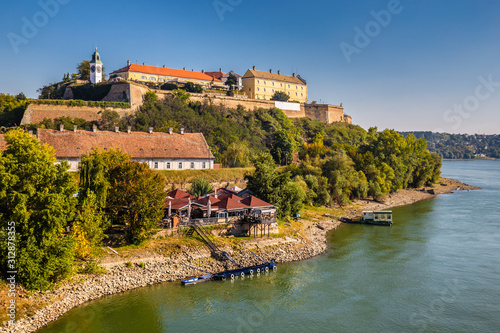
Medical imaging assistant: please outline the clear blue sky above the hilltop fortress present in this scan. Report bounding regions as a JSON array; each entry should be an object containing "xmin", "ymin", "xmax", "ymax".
[{"xmin": 0, "ymin": 0, "xmax": 500, "ymax": 134}]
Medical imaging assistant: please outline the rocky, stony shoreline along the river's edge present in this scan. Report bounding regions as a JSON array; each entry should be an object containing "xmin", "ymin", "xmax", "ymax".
[{"xmin": 0, "ymin": 178, "xmax": 479, "ymax": 333}]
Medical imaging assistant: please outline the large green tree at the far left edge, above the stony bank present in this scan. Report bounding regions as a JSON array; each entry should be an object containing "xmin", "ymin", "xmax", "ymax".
[{"xmin": 0, "ymin": 129, "xmax": 76, "ymax": 289}]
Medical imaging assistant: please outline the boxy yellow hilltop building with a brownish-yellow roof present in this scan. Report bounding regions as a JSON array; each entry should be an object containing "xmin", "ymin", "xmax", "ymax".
[{"xmin": 243, "ymin": 66, "xmax": 307, "ymax": 103}]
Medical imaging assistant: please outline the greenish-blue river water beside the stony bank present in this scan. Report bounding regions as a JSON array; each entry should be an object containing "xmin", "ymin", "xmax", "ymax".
[{"xmin": 40, "ymin": 161, "xmax": 500, "ymax": 333}]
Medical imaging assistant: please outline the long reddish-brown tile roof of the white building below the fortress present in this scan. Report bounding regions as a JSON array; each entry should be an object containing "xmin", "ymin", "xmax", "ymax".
[{"xmin": 37, "ymin": 128, "xmax": 214, "ymax": 159}]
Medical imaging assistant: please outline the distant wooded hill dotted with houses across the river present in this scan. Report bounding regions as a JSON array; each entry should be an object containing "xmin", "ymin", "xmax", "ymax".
[{"xmin": 399, "ymin": 132, "xmax": 500, "ymax": 159}]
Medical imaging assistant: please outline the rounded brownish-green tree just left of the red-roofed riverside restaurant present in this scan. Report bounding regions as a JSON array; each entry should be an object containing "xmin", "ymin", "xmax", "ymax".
[{"xmin": 107, "ymin": 161, "xmax": 165, "ymax": 244}]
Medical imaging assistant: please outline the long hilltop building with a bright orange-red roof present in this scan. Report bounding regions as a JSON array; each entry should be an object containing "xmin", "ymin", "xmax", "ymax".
[{"xmin": 111, "ymin": 61, "xmax": 223, "ymax": 88}]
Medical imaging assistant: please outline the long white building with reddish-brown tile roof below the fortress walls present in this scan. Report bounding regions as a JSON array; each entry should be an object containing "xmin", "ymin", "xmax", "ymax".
[{"xmin": 36, "ymin": 125, "xmax": 214, "ymax": 171}]
